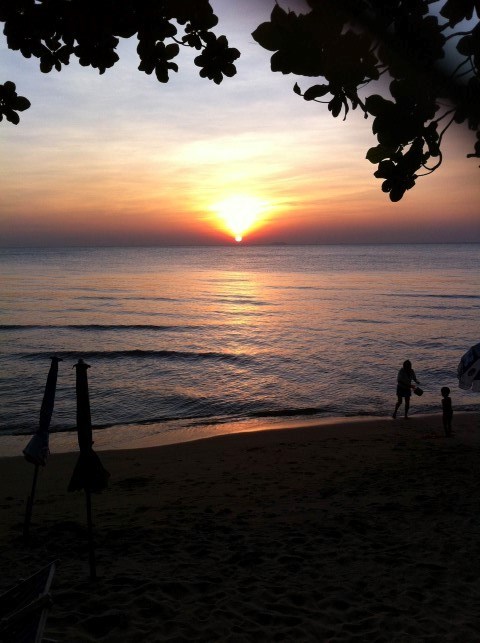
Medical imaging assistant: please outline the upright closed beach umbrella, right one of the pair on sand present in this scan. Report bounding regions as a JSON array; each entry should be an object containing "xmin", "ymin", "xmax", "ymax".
[{"xmin": 68, "ymin": 359, "xmax": 110, "ymax": 579}]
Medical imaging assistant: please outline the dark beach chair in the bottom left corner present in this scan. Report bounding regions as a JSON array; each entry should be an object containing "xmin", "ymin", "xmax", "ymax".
[{"xmin": 0, "ymin": 562, "xmax": 55, "ymax": 643}]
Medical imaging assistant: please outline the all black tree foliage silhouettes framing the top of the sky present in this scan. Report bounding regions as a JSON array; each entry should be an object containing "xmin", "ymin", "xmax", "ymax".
[{"xmin": 0, "ymin": 0, "xmax": 480, "ymax": 201}]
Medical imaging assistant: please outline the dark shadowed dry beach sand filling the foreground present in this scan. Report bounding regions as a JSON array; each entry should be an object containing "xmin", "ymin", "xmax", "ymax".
[{"xmin": 0, "ymin": 414, "xmax": 480, "ymax": 643}]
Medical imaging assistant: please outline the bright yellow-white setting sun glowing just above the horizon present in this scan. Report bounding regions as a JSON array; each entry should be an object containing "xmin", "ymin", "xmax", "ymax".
[{"xmin": 212, "ymin": 195, "xmax": 266, "ymax": 243}]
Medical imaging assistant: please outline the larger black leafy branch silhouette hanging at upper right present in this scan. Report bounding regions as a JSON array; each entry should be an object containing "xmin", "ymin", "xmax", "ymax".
[{"xmin": 253, "ymin": 0, "xmax": 480, "ymax": 201}]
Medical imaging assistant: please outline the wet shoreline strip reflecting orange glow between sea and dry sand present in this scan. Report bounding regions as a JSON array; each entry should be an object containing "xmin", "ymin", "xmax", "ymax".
[{"xmin": 0, "ymin": 411, "xmax": 475, "ymax": 458}]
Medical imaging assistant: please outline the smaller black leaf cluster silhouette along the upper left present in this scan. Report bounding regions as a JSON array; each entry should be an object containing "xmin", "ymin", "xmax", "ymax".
[{"xmin": 0, "ymin": 0, "xmax": 240, "ymax": 124}]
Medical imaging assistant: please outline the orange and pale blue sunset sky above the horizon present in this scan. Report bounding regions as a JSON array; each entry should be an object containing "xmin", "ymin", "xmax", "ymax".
[{"xmin": 0, "ymin": 0, "xmax": 480, "ymax": 246}]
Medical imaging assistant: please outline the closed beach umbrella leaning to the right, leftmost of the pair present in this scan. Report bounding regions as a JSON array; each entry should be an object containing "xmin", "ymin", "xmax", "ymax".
[{"xmin": 23, "ymin": 357, "xmax": 62, "ymax": 538}]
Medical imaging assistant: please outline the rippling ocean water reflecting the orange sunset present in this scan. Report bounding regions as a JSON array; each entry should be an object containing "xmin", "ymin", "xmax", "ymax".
[{"xmin": 0, "ymin": 244, "xmax": 480, "ymax": 446}]
